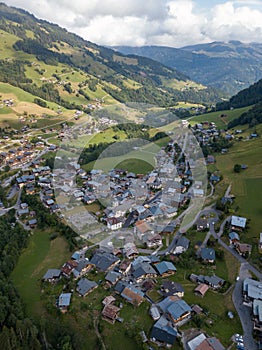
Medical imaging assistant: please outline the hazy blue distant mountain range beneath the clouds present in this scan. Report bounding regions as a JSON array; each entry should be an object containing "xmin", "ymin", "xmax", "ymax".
[{"xmin": 115, "ymin": 41, "xmax": 262, "ymax": 95}]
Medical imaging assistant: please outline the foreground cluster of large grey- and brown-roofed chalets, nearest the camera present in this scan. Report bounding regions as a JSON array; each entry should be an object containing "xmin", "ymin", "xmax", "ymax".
[{"xmin": 43, "ymin": 248, "xmax": 211, "ymax": 346}]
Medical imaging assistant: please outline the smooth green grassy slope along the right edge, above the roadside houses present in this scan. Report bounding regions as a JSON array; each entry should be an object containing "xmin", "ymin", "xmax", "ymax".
[{"xmin": 212, "ymin": 125, "xmax": 262, "ymax": 266}]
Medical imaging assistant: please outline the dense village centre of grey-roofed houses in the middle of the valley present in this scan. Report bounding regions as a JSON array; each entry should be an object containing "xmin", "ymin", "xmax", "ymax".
[{"xmin": 52, "ymin": 135, "xmax": 207, "ymax": 248}]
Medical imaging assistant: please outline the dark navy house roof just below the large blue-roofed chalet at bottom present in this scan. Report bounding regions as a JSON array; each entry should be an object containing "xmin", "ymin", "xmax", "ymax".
[{"xmin": 150, "ymin": 316, "xmax": 177, "ymax": 345}]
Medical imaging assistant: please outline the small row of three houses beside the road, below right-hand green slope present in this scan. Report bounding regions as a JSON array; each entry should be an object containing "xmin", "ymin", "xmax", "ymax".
[{"xmin": 228, "ymin": 215, "xmax": 252, "ymax": 258}]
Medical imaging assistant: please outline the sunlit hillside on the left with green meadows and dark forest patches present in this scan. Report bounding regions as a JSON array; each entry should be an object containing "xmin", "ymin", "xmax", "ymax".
[{"xmin": 0, "ymin": 3, "xmax": 222, "ymax": 122}]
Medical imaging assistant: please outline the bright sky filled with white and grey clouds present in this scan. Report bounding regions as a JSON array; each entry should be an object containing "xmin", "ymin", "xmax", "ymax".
[{"xmin": 3, "ymin": 0, "xmax": 262, "ymax": 47}]
